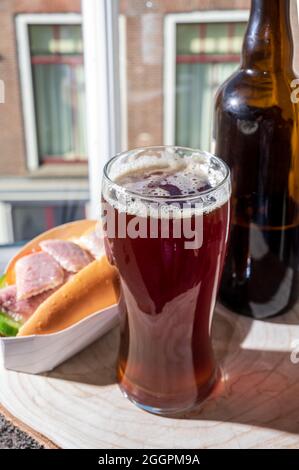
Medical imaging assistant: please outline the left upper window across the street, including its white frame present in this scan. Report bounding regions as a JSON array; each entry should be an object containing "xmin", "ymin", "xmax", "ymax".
[{"xmin": 17, "ymin": 14, "xmax": 87, "ymax": 170}]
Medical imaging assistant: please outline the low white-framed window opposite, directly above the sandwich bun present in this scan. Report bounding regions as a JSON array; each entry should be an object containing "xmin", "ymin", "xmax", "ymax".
[{"xmin": 0, "ymin": 178, "xmax": 89, "ymax": 245}]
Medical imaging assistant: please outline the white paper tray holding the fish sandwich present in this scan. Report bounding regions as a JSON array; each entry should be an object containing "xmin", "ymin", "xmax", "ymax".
[{"xmin": 0, "ymin": 305, "xmax": 118, "ymax": 374}]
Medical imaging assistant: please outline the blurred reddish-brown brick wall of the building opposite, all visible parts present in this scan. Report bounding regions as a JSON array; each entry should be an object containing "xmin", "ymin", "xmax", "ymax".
[{"xmin": 0, "ymin": 0, "xmax": 299, "ymax": 176}]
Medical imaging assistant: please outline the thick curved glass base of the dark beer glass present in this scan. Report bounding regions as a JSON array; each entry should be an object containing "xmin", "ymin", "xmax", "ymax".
[{"xmin": 118, "ymin": 368, "xmax": 222, "ymax": 417}]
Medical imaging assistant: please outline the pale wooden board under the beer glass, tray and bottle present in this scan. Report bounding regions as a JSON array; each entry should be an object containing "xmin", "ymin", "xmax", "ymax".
[{"xmin": 0, "ymin": 306, "xmax": 299, "ymax": 449}]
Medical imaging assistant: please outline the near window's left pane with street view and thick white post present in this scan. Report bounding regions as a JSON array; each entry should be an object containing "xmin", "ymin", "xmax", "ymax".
[{"xmin": 0, "ymin": 0, "xmax": 120, "ymax": 246}]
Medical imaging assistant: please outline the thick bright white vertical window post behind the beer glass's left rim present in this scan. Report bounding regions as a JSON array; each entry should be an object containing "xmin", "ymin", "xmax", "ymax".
[{"xmin": 82, "ymin": 0, "xmax": 121, "ymax": 219}]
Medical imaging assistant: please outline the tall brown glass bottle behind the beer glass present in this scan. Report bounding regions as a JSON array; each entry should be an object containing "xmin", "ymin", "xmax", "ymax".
[{"xmin": 215, "ymin": 0, "xmax": 299, "ymax": 318}]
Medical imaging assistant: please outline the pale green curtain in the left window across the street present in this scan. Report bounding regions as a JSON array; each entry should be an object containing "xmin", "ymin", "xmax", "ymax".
[{"xmin": 33, "ymin": 64, "xmax": 86, "ymax": 159}]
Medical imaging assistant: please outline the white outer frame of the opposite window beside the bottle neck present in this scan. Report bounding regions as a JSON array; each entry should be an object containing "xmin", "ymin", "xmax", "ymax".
[{"xmin": 163, "ymin": 10, "xmax": 249, "ymax": 145}]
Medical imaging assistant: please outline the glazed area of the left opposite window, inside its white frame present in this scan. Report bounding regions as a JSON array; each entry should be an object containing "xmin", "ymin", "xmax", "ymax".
[{"xmin": 29, "ymin": 25, "xmax": 86, "ymax": 163}]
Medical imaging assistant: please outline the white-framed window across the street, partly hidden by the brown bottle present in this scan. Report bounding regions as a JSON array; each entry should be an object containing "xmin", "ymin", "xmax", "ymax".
[{"xmin": 164, "ymin": 11, "xmax": 247, "ymax": 150}]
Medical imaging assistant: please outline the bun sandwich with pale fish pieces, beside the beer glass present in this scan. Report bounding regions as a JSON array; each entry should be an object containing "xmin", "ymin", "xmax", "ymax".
[{"xmin": 0, "ymin": 220, "xmax": 119, "ymax": 336}]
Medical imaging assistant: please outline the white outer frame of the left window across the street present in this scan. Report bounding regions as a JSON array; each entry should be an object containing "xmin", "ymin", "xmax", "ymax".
[{"xmin": 16, "ymin": 13, "xmax": 82, "ymax": 171}]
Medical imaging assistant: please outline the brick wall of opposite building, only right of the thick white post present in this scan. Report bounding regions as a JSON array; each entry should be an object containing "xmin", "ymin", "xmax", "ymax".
[{"xmin": 121, "ymin": 0, "xmax": 299, "ymax": 148}]
